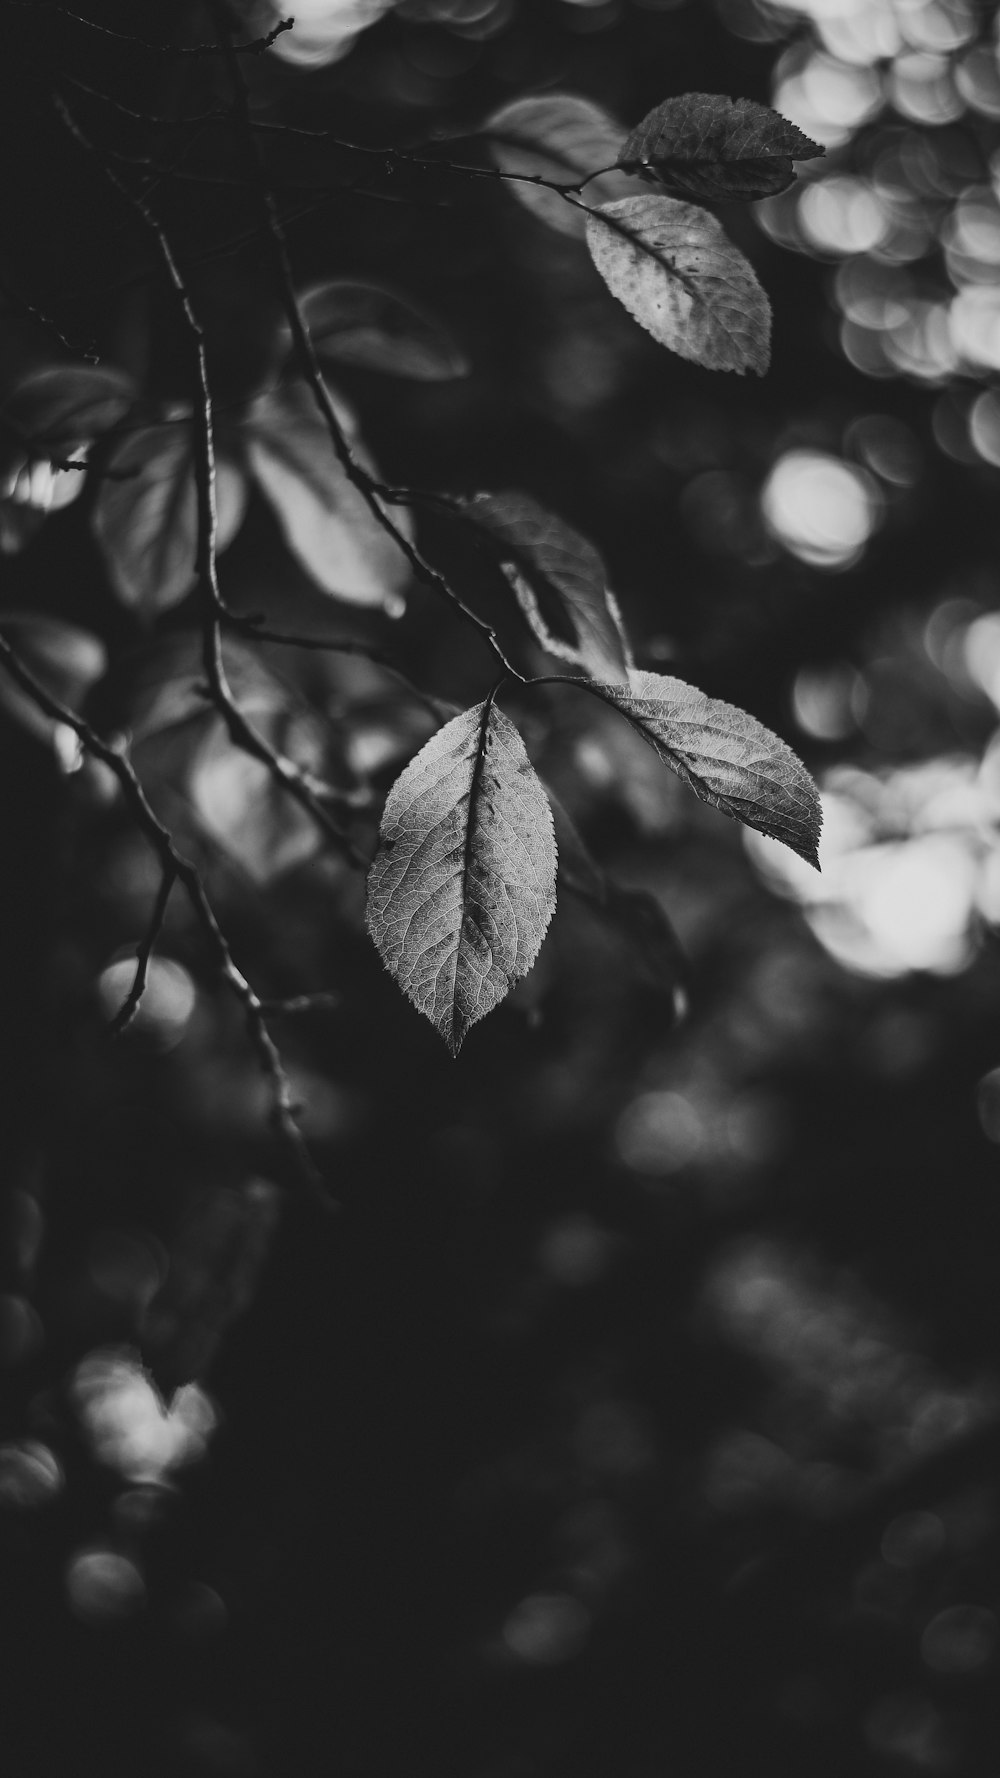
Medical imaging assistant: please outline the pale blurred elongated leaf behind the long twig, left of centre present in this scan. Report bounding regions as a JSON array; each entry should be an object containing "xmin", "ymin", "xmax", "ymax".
[{"xmin": 244, "ymin": 382, "xmax": 413, "ymax": 617}]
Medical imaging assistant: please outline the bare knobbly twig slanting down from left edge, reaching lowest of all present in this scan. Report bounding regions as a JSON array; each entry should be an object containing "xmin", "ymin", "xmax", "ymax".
[{"xmin": 0, "ymin": 635, "xmax": 336, "ymax": 1209}]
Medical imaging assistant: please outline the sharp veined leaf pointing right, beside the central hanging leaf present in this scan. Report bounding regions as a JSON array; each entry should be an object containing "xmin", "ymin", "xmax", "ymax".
[{"xmin": 607, "ymin": 669, "xmax": 822, "ymax": 869}]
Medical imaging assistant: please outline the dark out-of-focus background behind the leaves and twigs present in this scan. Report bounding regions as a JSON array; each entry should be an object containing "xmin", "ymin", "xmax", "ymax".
[{"xmin": 0, "ymin": 0, "xmax": 1000, "ymax": 1778}]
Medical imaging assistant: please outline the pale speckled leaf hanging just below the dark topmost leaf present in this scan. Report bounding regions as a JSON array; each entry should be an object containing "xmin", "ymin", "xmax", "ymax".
[{"xmin": 587, "ymin": 196, "xmax": 770, "ymax": 377}]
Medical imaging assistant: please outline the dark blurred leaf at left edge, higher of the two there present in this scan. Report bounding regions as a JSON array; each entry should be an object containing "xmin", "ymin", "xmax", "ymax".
[{"xmin": 0, "ymin": 364, "xmax": 135, "ymax": 459}]
